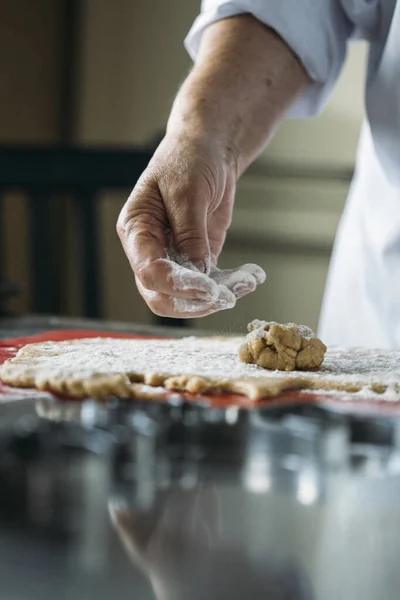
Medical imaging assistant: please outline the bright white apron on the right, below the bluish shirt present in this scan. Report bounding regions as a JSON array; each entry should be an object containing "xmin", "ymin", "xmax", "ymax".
[{"xmin": 319, "ymin": 122, "xmax": 400, "ymax": 348}]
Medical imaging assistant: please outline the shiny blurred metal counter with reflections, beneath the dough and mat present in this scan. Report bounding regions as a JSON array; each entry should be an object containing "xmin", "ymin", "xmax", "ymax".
[{"xmin": 0, "ymin": 319, "xmax": 400, "ymax": 600}]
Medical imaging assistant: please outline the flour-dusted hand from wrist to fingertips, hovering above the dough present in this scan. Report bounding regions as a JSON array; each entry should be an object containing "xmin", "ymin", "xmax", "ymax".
[{"xmin": 117, "ymin": 133, "xmax": 265, "ymax": 318}]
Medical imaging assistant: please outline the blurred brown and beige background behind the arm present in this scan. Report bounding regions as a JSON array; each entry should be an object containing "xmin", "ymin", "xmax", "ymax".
[{"xmin": 0, "ymin": 0, "xmax": 366, "ymax": 333}]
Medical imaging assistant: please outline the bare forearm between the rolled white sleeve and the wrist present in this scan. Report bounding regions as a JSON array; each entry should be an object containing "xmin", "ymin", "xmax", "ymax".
[{"xmin": 167, "ymin": 15, "xmax": 310, "ymax": 175}]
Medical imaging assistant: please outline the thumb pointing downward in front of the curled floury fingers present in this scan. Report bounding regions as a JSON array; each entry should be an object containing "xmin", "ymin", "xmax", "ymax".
[{"xmin": 166, "ymin": 189, "xmax": 210, "ymax": 273}]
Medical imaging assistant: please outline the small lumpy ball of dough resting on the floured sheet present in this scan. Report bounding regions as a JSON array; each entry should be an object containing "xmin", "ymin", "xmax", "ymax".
[{"xmin": 239, "ymin": 320, "xmax": 327, "ymax": 371}]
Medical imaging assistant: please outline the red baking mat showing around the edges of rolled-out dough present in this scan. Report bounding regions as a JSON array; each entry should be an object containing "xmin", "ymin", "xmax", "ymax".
[{"xmin": 0, "ymin": 329, "xmax": 400, "ymax": 416}]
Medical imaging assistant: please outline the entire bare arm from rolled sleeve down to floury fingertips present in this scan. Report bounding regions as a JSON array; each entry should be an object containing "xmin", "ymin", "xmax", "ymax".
[{"xmin": 118, "ymin": 15, "xmax": 310, "ymax": 317}]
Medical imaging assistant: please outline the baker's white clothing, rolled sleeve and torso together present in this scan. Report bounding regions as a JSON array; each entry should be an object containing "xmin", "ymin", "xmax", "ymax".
[{"xmin": 186, "ymin": 0, "xmax": 400, "ymax": 348}]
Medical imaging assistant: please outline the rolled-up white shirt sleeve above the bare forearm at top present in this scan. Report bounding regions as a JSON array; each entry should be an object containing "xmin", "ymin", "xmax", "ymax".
[{"xmin": 185, "ymin": 0, "xmax": 377, "ymax": 118}]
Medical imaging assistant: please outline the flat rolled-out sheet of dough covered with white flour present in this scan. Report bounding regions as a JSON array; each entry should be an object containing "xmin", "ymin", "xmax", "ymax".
[{"xmin": 0, "ymin": 338, "xmax": 400, "ymax": 401}]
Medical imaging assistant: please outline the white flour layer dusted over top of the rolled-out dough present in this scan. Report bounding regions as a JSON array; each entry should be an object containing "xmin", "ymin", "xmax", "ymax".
[{"xmin": 0, "ymin": 337, "xmax": 400, "ymax": 401}]
